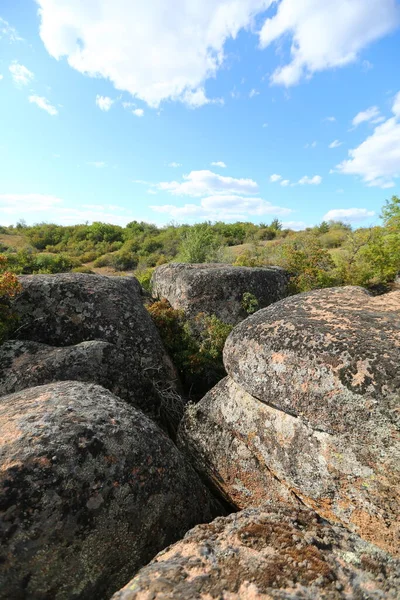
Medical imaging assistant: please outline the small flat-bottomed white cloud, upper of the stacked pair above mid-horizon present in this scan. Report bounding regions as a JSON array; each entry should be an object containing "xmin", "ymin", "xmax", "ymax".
[{"xmin": 155, "ymin": 170, "xmax": 258, "ymax": 196}]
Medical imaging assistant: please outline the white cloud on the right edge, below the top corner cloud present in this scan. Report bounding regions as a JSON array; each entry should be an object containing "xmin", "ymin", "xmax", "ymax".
[{"xmin": 336, "ymin": 93, "xmax": 400, "ymax": 189}]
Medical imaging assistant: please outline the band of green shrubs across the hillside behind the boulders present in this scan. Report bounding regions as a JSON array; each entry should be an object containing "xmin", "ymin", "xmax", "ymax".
[{"xmin": 0, "ymin": 196, "xmax": 400, "ymax": 292}]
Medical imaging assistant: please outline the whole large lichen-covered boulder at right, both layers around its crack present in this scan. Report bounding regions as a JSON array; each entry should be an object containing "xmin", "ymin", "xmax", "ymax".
[{"xmin": 179, "ymin": 288, "xmax": 400, "ymax": 553}]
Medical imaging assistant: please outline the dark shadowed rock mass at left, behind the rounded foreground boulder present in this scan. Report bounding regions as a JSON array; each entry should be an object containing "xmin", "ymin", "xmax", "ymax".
[{"xmin": 6, "ymin": 273, "xmax": 182, "ymax": 428}]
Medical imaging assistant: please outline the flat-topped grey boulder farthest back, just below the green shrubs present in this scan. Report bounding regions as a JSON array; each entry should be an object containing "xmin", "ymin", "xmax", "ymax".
[{"xmin": 152, "ymin": 263, "xmax": 289, "ymax": 325}]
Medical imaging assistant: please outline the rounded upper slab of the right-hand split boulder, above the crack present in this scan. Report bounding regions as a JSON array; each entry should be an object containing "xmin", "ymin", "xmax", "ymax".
[{"xmin": 224, "ymin": 287, "xmax": 400, "ymax": 433}]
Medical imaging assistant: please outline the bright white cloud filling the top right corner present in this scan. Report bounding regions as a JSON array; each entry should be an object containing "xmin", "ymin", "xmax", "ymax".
[{"xmin": 260, "ymin": 0, "xmax": 400, "ymax": 86}]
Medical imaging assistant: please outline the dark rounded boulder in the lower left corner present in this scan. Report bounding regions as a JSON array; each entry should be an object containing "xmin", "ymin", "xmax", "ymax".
[{"xmin": 0, "ymin": 382, "xmax": 222, "ymax": 600}]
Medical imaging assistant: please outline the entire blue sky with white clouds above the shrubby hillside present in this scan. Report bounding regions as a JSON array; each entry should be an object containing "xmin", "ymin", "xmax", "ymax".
[{"xmin": 0, "ymin": 0, "xmax": 400, "ymax": 229}]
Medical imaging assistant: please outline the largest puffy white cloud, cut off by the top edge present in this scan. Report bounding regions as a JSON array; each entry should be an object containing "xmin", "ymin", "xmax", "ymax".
[{"xmin": 37, "ymin": 0, "xmax": 272, "ymax": 107}]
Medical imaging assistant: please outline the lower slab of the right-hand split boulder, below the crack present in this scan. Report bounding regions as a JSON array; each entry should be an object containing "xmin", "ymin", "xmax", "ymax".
[{"xmin": 178, "ymin": 377, "xmax": 400, "ymax": 553}]
